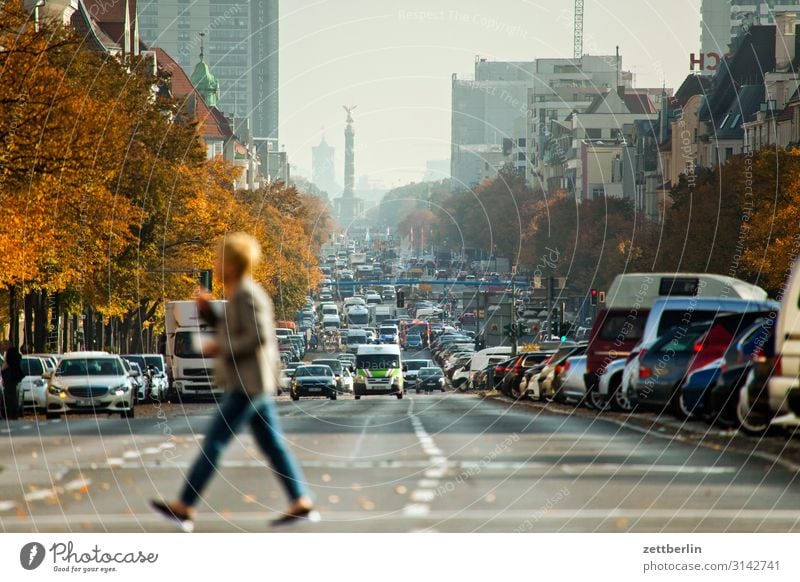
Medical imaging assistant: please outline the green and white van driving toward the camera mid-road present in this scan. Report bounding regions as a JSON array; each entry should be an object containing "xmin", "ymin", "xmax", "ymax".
[{"xmin": 353, "ymin": 344, "xmax": 405, "ymax": 400}]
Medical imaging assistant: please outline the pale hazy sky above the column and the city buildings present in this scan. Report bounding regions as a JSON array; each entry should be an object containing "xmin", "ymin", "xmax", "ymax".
[{"xmin": 280, "ymin": 0, "xmax": 700, "ymax": 187}]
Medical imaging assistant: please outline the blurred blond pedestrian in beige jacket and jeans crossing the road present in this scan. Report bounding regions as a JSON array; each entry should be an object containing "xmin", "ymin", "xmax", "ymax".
[{"xmin": 151, "ymin": 233, "xmax": 319, "ymax": 531}]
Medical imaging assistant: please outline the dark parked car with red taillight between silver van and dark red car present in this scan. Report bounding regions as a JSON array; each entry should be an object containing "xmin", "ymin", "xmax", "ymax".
[{"xmin": 630, "ymin": 321, "xmax": 711, "ymax": 415}]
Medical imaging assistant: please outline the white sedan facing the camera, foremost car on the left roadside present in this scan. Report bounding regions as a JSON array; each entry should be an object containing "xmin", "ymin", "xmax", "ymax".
[{"xmin": 46, "ymin": 352, "xmax": 135, "ymax": 419}]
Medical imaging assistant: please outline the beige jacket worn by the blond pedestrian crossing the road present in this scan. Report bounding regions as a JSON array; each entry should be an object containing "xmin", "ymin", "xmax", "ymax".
[{"xmin": 203, "ymin": 277, "xmax": 280, "ymax": 396}]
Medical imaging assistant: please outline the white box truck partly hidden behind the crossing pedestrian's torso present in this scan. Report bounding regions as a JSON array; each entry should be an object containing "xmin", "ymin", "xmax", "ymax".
[{"xmin": 164, "ymin": 301, "xmax": 225, "ymax": 399}]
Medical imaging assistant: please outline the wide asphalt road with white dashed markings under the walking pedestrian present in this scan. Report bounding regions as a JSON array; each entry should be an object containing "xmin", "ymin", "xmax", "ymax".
[{"xmin": 0, "ymin": 352, "xmax": 800, "ymax": 532}]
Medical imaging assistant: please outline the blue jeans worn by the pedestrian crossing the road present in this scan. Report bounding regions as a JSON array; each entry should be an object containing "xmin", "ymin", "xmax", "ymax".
[{"xmin": 181, "ymin": 391, "xmax": 310, "ymax": 506}]
